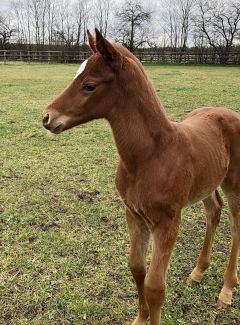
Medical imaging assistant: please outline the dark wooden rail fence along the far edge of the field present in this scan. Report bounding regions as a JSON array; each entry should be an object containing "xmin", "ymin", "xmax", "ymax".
[{"xmin": 0, "ymin": 49, "xmax": 240, "ymax": 64}]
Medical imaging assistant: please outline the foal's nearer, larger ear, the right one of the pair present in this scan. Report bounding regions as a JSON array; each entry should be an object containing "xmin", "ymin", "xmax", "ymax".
[{"xmin": 95, "ymin": 28, "xmax": 122, "ymax": 69}]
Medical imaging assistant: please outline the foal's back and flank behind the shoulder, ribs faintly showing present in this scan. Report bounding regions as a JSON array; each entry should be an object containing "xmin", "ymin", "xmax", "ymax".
[{"xmin": 179, "ymin": 107, "xmax": 240, "ymax": 203}]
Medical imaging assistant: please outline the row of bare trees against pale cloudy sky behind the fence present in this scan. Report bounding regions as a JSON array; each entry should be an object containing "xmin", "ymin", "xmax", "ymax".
[{"xmin": 0, "ymin": 0, "xmax": 240, "ymax": 63}]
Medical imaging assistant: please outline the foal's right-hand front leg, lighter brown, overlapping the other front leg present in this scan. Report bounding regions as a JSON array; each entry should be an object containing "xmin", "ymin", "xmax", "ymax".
[{"xmin": 144, "ymin": 214, "xmax": 180, "ymax": 325}]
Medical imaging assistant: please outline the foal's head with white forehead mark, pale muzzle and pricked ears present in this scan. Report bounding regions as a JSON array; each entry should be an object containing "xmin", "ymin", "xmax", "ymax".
[{"xmin": 43, "ymin": 30, "xmax": 143, "ymax": 133}]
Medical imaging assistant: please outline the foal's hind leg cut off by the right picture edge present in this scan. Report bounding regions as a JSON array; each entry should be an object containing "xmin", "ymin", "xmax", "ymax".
[{"xmin": 218, "ymin": 181, "xmax": 240, "ymax": 307}]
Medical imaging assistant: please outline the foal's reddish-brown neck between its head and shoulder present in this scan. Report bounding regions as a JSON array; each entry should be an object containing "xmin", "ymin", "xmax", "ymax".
[{"xmin": 108, "ymin": 64, "xmax": 172, "ymax": 173}]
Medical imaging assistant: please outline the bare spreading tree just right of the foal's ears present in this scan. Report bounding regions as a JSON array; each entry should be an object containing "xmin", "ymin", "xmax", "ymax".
[{"xmin": 116, "ymin": 0, "xmax": 151, "ymax": 52}]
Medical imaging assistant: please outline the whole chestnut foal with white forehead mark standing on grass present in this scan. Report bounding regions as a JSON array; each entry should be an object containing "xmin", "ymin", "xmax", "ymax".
[{"xmin": 43, "ymin": 30, "xmax": 240, "ymax": 325}]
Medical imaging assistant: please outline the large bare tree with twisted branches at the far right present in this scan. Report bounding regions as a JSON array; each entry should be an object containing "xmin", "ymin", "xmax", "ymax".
[{"xmin": 195, "ymin": 0, "xmax": 240, "ymax": 64}]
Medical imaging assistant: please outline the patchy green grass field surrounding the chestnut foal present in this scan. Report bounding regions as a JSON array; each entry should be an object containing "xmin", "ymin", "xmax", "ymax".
[{"xmin": 0, "ymin": 64, "xmax": 240, "ymax": 325}]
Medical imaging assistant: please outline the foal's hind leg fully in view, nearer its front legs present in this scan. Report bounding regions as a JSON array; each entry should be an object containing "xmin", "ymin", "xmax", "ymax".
[{"xmin": 188, "ymin": 190, "xmax": 223, "ymax": 283}]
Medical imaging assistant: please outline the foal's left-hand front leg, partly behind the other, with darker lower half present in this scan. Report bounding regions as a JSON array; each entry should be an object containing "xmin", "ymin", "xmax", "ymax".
[{"xmin": 126, "ymin": 209, "xmax": 150, "ymax": 325}]
